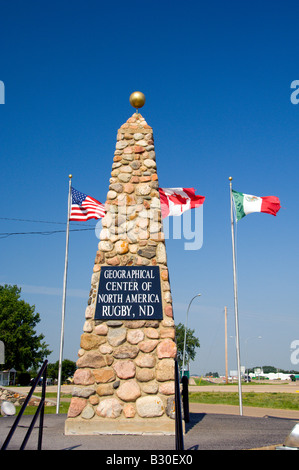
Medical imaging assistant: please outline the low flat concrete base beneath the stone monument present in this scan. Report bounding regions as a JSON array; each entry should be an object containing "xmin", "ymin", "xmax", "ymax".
[{"xmin": 64, "ymin": 417, "xmax": 175, "ymax": 436}]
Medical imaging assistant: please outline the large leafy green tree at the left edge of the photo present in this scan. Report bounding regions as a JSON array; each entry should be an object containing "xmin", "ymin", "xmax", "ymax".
[{"xmin": 0, "ymin": 284, "xmax": 52, "ymax": 372}]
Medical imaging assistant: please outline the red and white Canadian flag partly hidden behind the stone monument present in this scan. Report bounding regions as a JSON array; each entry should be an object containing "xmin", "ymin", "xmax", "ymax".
[{"xmin": 159, "ymin": 188, "xmax": 205, "ymax": 219}]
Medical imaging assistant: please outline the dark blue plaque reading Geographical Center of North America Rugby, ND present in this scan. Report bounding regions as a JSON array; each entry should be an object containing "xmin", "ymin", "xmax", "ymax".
[{"xmin": 94, "ymin": 266, "xmax": 163, "ymax": 320}]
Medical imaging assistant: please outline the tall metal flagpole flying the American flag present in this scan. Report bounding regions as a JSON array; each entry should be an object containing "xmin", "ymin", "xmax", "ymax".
[{"xmin": 56, "ymin": 175, "xmax": 72, "ymax": 414}]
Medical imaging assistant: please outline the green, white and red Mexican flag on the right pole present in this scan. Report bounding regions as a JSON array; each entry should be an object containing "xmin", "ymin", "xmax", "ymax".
[{"xmin": 232, "ymin": 190, "xmax": 280, "ymax": 220}]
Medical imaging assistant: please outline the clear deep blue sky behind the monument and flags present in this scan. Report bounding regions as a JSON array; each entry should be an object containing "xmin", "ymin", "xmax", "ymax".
[{"xmin": 0, "ymin": 0, "xmax": 299, "ymax": 374}]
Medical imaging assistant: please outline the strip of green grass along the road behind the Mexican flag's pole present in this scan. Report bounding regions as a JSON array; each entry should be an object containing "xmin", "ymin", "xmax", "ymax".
[{"xmin": 189, "ymin": 392, "xmax": 299, "ymax": 410}]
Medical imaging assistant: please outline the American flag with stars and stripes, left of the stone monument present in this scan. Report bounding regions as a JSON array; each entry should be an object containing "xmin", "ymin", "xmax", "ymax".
[{"xmin": 70, "ymin": 188, "xmax": 105, "ymax": 221}]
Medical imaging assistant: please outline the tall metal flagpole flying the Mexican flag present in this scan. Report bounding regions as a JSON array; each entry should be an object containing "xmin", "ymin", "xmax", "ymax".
[{"xmin": 229, "ymin": 176, "xmax": 243, "ymax": 416}]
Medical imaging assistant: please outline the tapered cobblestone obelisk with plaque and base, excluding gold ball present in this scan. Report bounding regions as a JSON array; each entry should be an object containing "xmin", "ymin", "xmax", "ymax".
[{"xmin": 65, "ymin": 101, "xmax": 176, "ymax": 435}]
